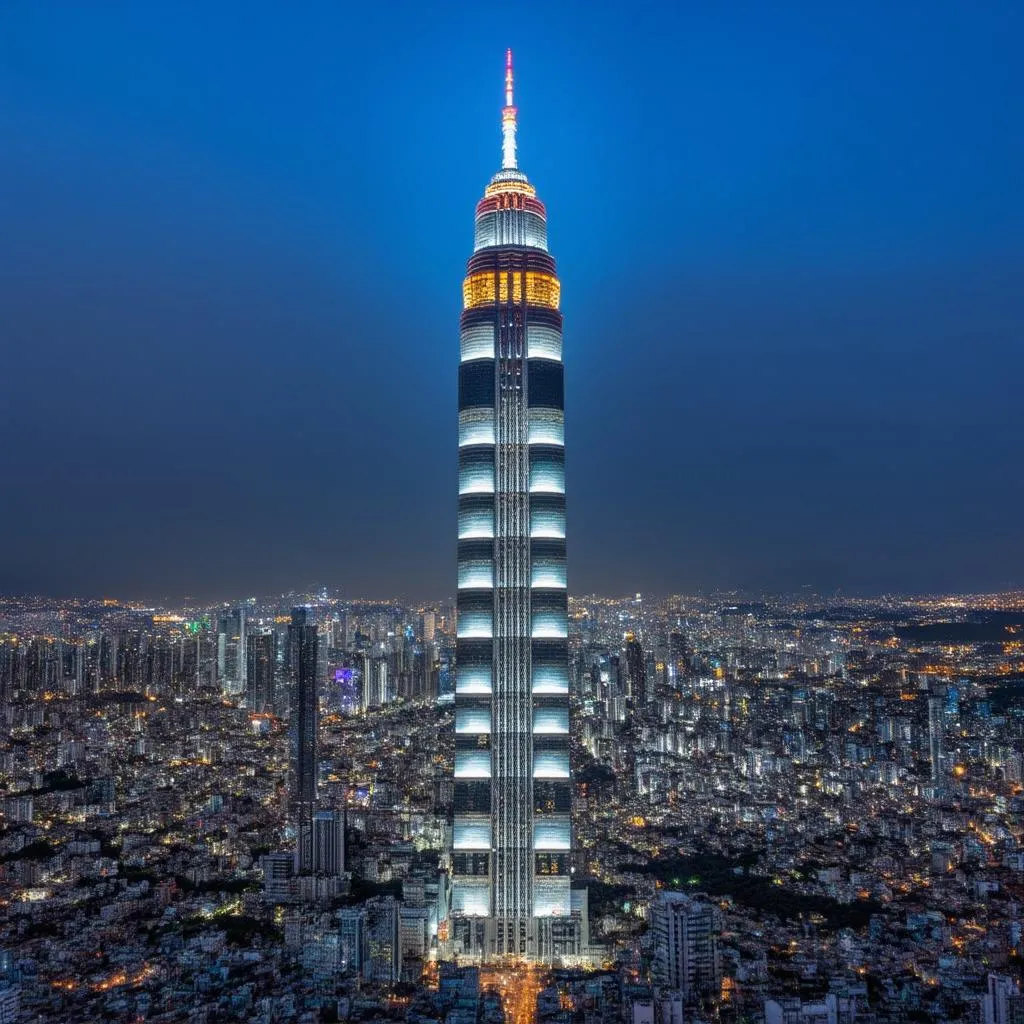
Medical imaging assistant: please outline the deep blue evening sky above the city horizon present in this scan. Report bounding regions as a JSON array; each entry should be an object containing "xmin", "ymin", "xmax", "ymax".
[{"xmin": 0, "ymin": 0, "xmax": 1024, "ymax": 599}]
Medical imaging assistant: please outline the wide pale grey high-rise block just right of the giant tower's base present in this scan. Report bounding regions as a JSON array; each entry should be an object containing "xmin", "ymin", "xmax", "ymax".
[{"xmin": 651, "ymin": 892, "xmax": 722, "ymax": 1002}]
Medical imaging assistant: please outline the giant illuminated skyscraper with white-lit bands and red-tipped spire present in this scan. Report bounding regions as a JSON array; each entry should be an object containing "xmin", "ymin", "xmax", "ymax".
[{"xmin": 452, "ymin": 51, "xmax": 579, "ymax": 959}]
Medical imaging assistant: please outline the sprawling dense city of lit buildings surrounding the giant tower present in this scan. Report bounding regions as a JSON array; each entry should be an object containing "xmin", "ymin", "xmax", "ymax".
[{"xmin": 0, "ymin": 592, "xmax": 1024, "ymax": 1024}]
